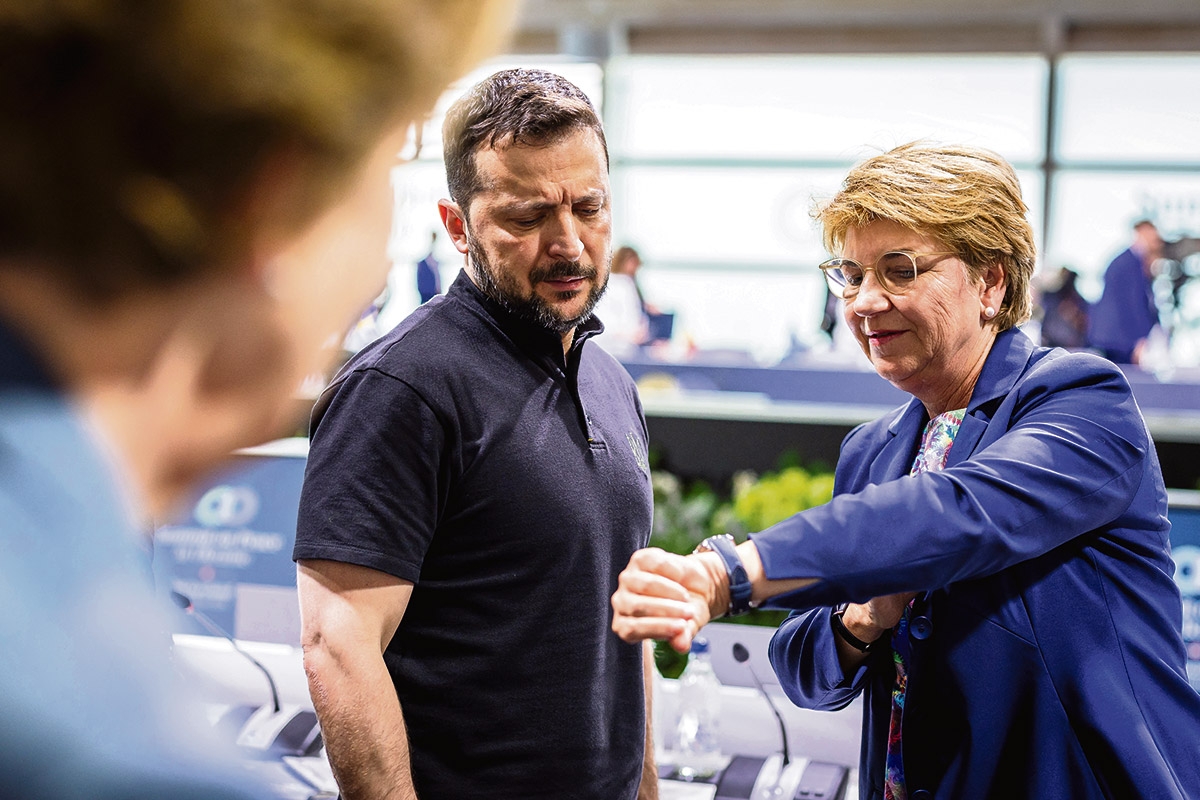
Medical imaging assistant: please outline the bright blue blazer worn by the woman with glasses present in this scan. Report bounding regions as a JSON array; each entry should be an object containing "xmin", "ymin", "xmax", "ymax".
[{"xmin": 752, "ymin": 330, "xmax": 1200, "ymax": 800}]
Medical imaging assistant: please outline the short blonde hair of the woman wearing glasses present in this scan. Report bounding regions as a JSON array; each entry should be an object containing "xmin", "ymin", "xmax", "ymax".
[{"xmin": 814, "ymin": 142, "xmax": 1037, "ymax": 330}]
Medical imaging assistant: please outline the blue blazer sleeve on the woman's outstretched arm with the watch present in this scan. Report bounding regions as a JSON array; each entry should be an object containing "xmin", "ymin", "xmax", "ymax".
[{"xmin": 752, "ymin": 351, "xmax": 1165, "ymax": 608}]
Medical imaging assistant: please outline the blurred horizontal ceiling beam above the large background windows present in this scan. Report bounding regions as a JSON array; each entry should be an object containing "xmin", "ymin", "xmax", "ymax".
[{"xmin": 512, "ymin": 0, "xmax": 1200, "ymax": 60}]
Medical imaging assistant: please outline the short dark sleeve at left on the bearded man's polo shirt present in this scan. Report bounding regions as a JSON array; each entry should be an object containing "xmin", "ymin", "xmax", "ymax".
[{"xmin": 293, "ymin": 369, "xmax": 445, "ymax": 583}]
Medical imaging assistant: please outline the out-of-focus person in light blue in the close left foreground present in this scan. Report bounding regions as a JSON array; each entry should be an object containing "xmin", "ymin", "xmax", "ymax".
[{"xmin": 0, "ymin": 0, "xmax": 510, "ymax": 799}]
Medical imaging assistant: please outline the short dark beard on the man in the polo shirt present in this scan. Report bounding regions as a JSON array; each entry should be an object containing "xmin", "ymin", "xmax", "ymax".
[{"xmin": 467, "ymin": 239, "xmax": 608, "ymax": 336}]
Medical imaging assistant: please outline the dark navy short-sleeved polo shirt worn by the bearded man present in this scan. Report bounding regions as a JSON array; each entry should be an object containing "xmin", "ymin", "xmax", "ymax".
[{"xmin": 294, "ymin": 273, "xmax": 652, "ymax": 800}]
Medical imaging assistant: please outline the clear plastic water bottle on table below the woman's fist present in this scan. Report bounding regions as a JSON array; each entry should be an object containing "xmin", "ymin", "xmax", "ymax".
[{"xmin": 674, "ymin": 639, "xmax": 725, "ymax": 781}]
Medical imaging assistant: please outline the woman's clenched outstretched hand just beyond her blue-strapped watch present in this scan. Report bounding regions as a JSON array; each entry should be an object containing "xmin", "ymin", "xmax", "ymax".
[{"xmin": 612, "ymin": 547, "xmax": 728, "ymax": 652}]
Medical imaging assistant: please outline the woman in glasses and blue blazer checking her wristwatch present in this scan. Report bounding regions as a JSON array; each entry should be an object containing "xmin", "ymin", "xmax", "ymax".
[{"xmin": 612, "ymin": 143, "xmax": 1200, "ymax": 800}]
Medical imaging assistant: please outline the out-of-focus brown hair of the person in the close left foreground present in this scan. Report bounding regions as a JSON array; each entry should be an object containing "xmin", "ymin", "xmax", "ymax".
[{"xmin": 0, "ymin": 0, "xmax": 512, "ymax": 301}]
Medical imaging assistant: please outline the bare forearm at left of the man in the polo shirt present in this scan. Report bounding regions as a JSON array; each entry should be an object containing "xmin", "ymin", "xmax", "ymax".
[{"xmin": 305, "ymin": 649, "xmax": 416, "ymax": 800}]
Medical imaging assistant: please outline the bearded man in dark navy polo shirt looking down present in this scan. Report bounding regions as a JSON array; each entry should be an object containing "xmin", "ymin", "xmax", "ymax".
[{"xmin": 294, "ymin": 70, "xmax": 656, "ymax": 800}]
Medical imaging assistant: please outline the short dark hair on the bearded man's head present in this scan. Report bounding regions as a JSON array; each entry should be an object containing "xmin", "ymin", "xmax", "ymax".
[{"xmin": 442, "ymin": 68, "xmax": 608, "ymax": 216}]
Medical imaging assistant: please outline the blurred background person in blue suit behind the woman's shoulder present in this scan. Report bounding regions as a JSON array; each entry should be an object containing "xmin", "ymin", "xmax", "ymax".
[{"xmin": 1087, "ymin": 219, "xmax": 1163, "ymax": 365}]
